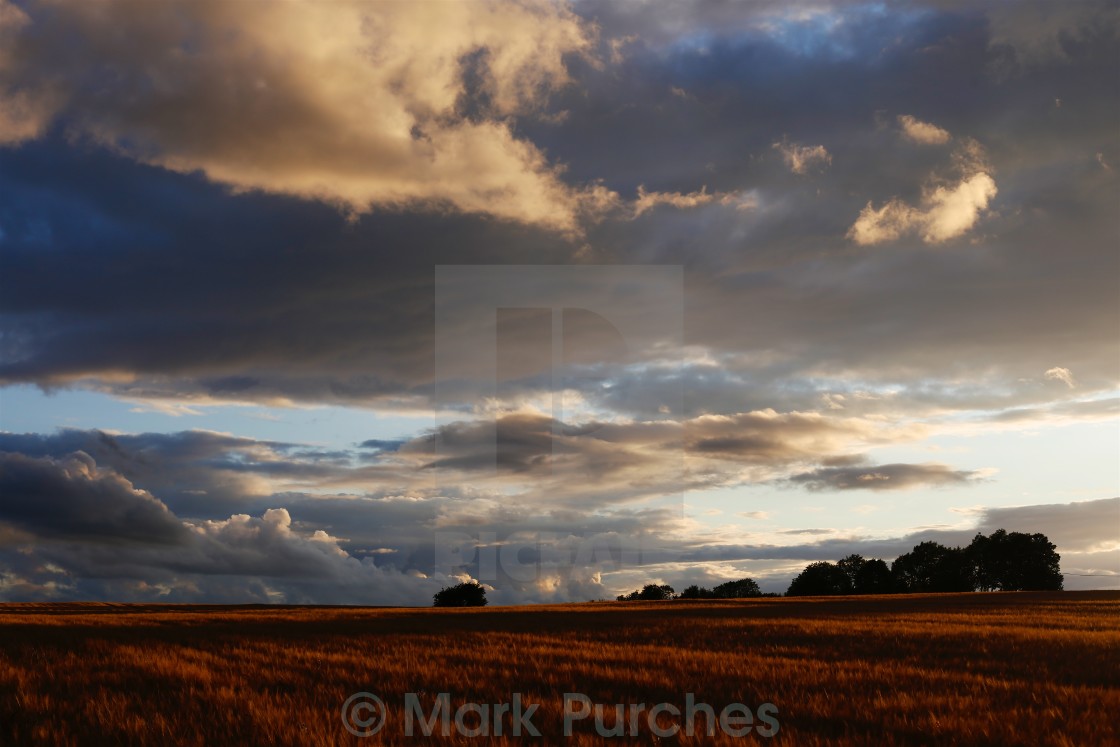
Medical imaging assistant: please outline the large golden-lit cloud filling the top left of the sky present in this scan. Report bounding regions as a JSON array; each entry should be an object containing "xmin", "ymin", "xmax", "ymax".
[{"xmin": 0, "ymin": 0, "xmax": 614, "ymax": 231}]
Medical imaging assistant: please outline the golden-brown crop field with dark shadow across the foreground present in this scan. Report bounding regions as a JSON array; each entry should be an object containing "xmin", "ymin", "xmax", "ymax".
[{"xmin": 0, "ymin": 591, "xmax": 1120, "ymax": 747}]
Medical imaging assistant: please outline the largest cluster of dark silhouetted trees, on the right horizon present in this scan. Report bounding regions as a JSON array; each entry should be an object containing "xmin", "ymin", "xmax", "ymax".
[{"xmin": 786, "ymin": 530, "xmax": 1062, "ymax": 597}]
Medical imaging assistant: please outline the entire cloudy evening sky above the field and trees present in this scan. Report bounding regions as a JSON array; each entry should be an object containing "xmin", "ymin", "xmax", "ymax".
[{"xmin": 0, "ymin": 0, "xmax": 1120, "ymax": 605}]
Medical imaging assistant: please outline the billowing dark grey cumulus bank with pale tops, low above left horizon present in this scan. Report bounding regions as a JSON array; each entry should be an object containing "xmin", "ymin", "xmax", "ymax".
[{"xmin": 0, "ymin": 452, "xmax": 456, "ymax": 604}]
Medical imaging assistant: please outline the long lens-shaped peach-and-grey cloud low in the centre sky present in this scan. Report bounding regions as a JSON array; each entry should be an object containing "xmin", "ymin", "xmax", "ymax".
[{"xmin": 409, "ymin": 410, "xmax": 922, "ymax": 497}]
